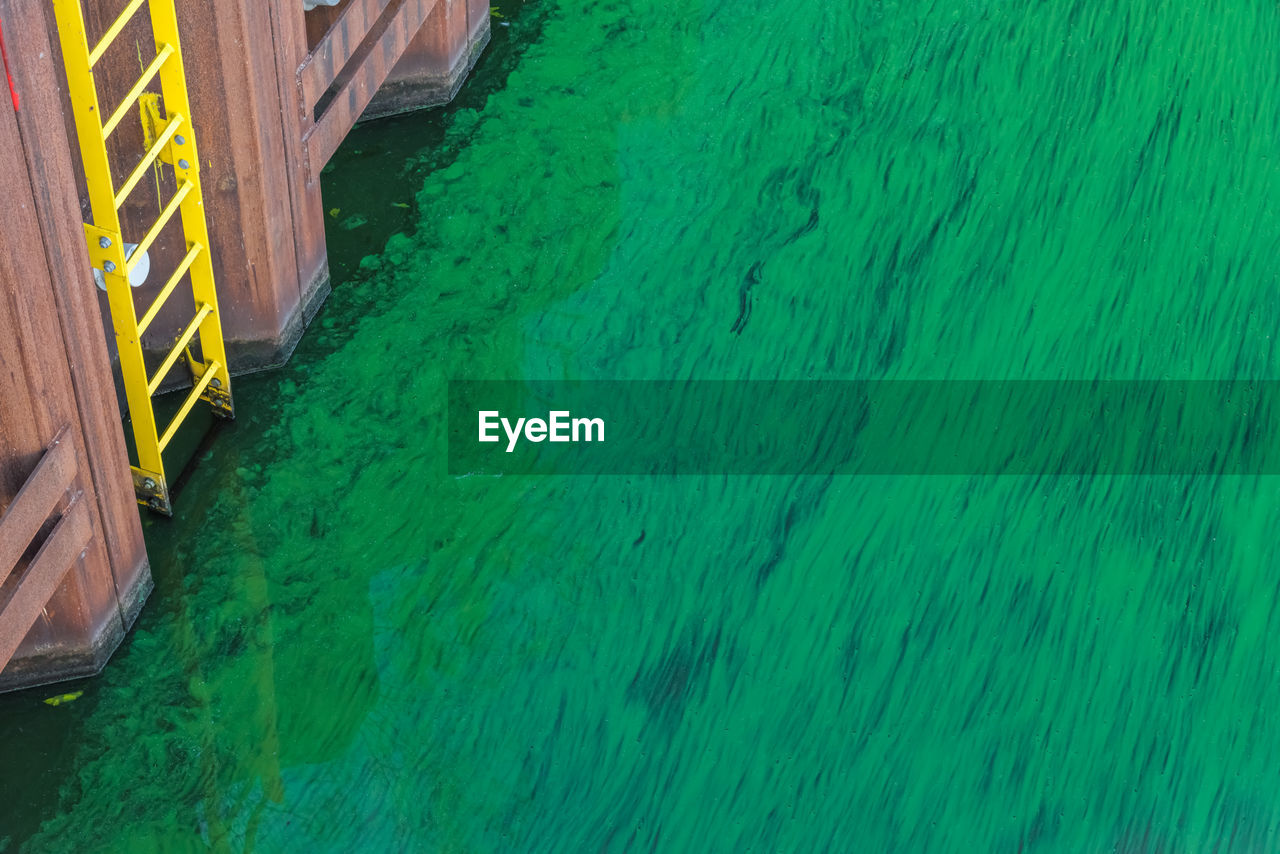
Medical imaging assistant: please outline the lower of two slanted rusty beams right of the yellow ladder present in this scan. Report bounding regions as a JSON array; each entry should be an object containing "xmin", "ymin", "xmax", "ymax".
[{"xmin": 303, "ymin": 0, "xmax": 437, "ymax": 174}]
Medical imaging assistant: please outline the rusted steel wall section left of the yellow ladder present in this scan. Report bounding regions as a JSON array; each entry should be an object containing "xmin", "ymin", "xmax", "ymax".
[{"xmin": 0, "ymin": 0, "xmax": 151, "ymax": 690}]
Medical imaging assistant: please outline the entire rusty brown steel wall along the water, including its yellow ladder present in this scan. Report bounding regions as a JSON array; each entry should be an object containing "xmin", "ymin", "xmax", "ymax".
[{"xmin": 0, "ymin": 0, "xmax": 489, "ymax": 690}]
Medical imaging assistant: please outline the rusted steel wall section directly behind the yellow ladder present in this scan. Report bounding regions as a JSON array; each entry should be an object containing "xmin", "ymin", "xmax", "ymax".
[{"xmin": 59, "ymin": 0, "xmax": 329, "ymax": 378}]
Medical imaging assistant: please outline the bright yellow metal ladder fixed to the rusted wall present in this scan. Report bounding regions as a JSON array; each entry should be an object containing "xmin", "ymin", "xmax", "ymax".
[{"xmin": 52, "ymin": 0, "xmax": 234, "ymax": 515}]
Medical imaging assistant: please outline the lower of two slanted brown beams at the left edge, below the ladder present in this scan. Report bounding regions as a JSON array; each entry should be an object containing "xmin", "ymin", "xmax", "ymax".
[{"xmin": 0, "ymin": 499, "xmax": 93, "ymax": 670}]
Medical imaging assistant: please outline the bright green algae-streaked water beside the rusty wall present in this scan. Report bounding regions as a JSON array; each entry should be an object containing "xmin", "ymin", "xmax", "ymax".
[{"xmin": 0, "ymin": 0, "xmax": 1280, "ymax": 854}]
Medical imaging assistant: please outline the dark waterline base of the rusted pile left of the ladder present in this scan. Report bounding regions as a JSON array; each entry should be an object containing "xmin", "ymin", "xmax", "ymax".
[{"xmin": 0, "ymin": 561, "xmax": 155, "ymax": 694}]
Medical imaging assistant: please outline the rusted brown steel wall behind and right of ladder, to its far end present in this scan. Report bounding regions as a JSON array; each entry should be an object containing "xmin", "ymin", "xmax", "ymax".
[{"xmin": 47, "ymin": 0, "xmax": 489, "ymax": 378}]
